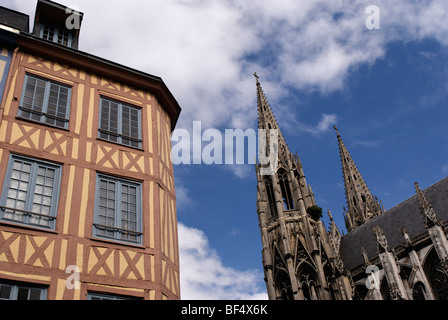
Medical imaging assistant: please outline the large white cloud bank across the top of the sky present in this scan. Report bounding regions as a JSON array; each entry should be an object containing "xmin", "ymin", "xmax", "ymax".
[{"xmin": 8, "ymin": 0, "xmax": 448, "ymax": 135}]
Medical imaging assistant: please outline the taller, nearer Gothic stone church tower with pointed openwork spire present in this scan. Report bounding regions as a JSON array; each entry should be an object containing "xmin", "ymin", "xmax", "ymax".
[{"xmin": 254, "ymin": 74, "xmax": 352, "ymax": 300}]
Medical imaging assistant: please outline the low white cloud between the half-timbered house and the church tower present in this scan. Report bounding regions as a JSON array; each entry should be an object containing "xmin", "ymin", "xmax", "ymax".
[{"xmin": 178, "ymin": 223, "xmax": 267, "ymax": 300}]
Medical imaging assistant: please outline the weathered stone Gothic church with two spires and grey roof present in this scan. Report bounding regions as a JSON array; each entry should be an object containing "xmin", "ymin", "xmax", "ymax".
[{"xmin": 255, "ymin": 75, "xmax": 448, "ymax": 300}]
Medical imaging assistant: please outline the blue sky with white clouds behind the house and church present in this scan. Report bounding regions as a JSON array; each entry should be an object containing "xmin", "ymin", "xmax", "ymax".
[{"xmin": 5, "ymin": 0, "xmax": 448, "ymax": 300}]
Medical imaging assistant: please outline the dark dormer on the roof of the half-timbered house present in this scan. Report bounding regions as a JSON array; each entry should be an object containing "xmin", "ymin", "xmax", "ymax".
[{"xmin": 33, "ymin": 0, "xmax": 83, "ymax": 49}]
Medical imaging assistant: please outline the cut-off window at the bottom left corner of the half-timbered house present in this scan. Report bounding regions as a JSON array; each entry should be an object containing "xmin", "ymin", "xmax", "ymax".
[{"xmin": 0, "ymin": 282, "xmax": 47, "ymax": 300}]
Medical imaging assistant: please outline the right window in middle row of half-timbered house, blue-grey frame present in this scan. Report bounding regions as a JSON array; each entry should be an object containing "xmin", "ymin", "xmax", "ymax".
[{"xmin": 93, "ymin": 174, "xmax": 142, "ymax": 244}]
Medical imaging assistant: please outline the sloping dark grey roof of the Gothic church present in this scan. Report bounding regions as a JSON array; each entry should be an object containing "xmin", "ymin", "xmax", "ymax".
[{"xmin": 340, "ymin": 177, "xmax": 448, "ymax": 270}]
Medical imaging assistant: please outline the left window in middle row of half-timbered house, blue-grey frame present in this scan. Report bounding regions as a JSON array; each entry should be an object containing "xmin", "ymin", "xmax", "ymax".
[{"xmin": 0, "ymin": 155, "xmax": 61, "ymax": 230}]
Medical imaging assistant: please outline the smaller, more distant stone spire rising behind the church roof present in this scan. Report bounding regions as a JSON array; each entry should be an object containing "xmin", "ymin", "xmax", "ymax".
[{"xmin": 334, "ymin": 126, "xmax": 383, "ymax": 232}]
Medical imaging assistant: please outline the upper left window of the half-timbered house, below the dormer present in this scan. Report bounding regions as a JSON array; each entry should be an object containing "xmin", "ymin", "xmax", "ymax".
[{"xmin": 19, "ymin": 75, "xmax": 71, "ymax": 129}]
